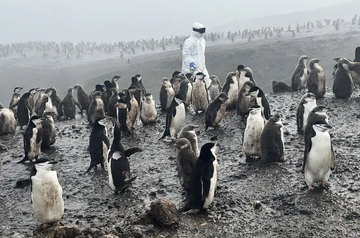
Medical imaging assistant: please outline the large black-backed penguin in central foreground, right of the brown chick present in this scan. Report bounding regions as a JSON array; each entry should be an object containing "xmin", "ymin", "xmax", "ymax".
[{"xmin": 180, "ymin": 143, "xmax": 219, "ymax": 212}]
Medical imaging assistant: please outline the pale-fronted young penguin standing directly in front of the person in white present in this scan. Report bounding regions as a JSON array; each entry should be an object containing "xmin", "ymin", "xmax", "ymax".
[{"xmin": 191, "ymin": 72, "xmax": 209, "ymax": 114}]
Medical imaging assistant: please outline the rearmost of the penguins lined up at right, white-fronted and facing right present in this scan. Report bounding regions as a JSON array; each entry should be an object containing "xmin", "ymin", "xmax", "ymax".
[{"xmin": 296, "ymin": 93, "xmax": 317, "ymax": 134}]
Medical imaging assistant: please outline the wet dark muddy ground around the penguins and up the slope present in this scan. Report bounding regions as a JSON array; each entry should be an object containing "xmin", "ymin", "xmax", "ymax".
[{"xmin": 0, "ymin": 24, "xmax": 360, "ymax": 237}]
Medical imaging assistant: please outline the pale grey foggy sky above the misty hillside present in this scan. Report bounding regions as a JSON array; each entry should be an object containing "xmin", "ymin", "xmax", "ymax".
[{"xmin": 0, "ymin": 0, "xmax": 349, "ymax": 43}]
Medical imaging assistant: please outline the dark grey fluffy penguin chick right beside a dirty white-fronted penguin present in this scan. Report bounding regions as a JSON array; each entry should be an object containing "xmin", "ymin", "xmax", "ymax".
[{"xmin": 260, "ymin": 115, "xmax": 285, "ymax": 164}]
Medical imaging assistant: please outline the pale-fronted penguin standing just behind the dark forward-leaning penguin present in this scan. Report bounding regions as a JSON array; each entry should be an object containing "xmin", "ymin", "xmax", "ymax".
[{"xmin": 223, "ymin": 72, "xmax": 239, "ymax": 109}]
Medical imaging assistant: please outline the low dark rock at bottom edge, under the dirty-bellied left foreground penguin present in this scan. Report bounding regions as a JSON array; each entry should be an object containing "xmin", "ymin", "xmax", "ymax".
[{"xmin": 33, "ymin": 225, "xmax": 80, "ymax": 238}]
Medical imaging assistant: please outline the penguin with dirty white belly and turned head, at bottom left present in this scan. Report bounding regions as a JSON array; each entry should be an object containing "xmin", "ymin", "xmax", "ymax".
[{"xmin": 30, "ymin": 158, "xmax": 64, "ymax": 225}]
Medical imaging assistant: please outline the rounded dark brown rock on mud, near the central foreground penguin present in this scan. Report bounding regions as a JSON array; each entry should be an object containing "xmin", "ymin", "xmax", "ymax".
[{"xmin": 150, "ymin": 198, "xmax": 180, "ymax": 227}]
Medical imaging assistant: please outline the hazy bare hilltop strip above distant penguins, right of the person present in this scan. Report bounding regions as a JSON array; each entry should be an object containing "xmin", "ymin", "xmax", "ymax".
[{"xmin": 209, "ymin": 1, "xmax": 360, "ymax": 32}]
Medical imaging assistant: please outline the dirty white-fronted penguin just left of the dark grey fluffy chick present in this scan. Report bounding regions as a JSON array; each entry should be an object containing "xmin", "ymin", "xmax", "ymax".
[{"xmin": 243, "ymin": 105, "xmax": 265, "ymax": 159}]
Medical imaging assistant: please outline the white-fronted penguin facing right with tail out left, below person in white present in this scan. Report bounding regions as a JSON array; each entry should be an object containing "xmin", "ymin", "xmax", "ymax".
[{"xmin": 159, "ymin": 96, "xmax": 185, "ymax": 140}]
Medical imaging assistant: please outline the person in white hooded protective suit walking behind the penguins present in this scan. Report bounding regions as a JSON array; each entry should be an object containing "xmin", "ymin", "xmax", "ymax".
[{"xmin": 181, "ymin": 22, "xmax": 211, "ymax": 88}]
